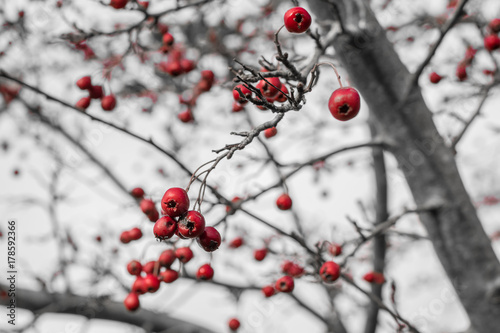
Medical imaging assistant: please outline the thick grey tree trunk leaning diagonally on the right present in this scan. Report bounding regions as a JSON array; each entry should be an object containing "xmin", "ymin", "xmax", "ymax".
[{"xmin": 311, "ymin": 1, "xmax": 500, "ymax": 333}]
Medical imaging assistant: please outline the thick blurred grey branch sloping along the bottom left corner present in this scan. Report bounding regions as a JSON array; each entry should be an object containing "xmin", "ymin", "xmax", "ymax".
[{"xmin": 0, "ymin": 285, "xmax": 213, "ymax": 333}]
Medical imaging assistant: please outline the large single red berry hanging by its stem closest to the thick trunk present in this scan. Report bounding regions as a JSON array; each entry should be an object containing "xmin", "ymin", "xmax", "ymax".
[{"xmin": 328, "ymin": 87, "xmax": 360, "ymax": 121}]
